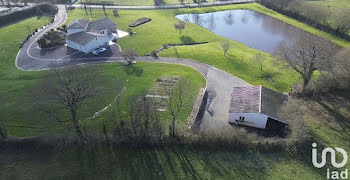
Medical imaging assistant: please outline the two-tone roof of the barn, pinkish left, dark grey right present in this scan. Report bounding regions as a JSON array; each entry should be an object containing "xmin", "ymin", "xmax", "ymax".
[{"xmin": 229, "ymin": 86, "xmax": 287, "ymax": 119}]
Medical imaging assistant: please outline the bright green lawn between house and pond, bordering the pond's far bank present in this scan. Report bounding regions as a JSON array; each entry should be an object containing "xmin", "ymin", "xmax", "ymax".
[{"xmin": 67, "ymin": 3, "xmax": 350, "ymax": 92}]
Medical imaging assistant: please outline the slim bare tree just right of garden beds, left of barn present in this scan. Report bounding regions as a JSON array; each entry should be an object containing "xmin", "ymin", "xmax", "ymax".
[{"xmin": 164, "ymin": 78, "xmax": 194, "ymax": 136}]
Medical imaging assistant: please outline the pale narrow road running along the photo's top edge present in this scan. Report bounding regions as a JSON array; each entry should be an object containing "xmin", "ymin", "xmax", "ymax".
[{"xmin": 73, "ymin": 0, "xmax": 255, "ymax": 10}]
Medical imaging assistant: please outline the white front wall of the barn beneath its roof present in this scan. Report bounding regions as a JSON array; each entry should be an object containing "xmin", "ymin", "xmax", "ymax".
[{"xmin": 229, "ymin": 113, "xmax": 268, "ymax": 129}]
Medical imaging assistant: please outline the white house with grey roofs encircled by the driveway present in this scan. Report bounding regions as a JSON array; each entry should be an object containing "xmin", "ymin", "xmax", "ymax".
[{"xmin": 66, "ymin": 18, "xmax": 118, "ymax": 53}]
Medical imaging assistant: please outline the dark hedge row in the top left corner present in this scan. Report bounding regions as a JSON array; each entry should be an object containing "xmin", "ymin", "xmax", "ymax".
[{"xmin": 0, "ymin": 4, "xmax": 57, "ymax": 26}]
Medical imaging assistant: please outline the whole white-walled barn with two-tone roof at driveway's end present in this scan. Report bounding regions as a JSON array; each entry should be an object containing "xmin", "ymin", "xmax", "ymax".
[{"xmin": 228, "ymin": 86, "xmax": 288, "ymax": 134}]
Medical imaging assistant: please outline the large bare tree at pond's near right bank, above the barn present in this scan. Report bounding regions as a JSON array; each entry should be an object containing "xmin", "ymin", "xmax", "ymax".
[{"xmin": 275, "ymin": 34, "xmax": 335, "ymax": 91}]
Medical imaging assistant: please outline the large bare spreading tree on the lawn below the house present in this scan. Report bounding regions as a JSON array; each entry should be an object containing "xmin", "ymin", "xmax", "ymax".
[{"xmin": 31, "ymin": 67, "xmax": 101, "ymax": 142}]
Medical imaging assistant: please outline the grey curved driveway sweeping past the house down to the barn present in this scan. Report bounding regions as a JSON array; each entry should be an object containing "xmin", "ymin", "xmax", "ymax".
[{"xmin": 16, "ymin": 6, "xmax": 248, "ymax": 133}]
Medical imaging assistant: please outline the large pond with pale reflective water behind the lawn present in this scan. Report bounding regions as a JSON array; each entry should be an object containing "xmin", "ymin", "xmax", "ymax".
[{"xmin": 176, "ymin": 10, "xmax": 314, "ymax": 53}]
